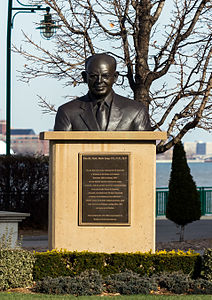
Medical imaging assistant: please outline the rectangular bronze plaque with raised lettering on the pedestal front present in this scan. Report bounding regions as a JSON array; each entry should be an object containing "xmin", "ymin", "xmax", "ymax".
[{"xmin": 79, "ymin": 152, "xmax": 130, "ymax": 226}]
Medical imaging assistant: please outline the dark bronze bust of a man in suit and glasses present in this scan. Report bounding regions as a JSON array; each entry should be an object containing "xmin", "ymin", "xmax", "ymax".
[{"xmin": 54, "ymin": 53, "xmax": 151, "ymax": 131}]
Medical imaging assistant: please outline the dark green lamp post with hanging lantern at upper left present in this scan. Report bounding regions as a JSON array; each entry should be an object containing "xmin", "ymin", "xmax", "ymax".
[{"xmin": 6, "ymin": 0, "xmax": 57, "ymax": 155}]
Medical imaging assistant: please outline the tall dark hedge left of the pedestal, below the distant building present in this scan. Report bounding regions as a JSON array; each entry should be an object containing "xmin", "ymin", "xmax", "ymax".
[{"xmin": 0, "ymin": 155, "xmax": 49, "ymax": 229}]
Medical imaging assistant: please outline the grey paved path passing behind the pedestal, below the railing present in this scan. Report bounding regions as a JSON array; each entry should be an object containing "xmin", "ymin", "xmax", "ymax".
[{"xmin": 19, "ymin": 218, "xmax": 212, "ymax": 249}]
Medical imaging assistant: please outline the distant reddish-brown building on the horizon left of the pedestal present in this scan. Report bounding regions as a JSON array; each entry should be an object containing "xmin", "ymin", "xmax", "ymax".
[{"xmin": 0, "ymin": 121, "xmax": 49, "ymax": 155}]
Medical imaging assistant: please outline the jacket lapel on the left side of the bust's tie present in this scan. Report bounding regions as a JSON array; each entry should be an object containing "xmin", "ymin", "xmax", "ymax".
[{"xmin": 80, "ymin": 95, "xmax": 98, "ymax": 131}]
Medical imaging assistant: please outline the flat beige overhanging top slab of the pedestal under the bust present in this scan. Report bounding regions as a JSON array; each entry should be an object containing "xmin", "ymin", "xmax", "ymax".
[{"xmin": 40, "ymin": 131, "xmax": 167, "ymax": 141}]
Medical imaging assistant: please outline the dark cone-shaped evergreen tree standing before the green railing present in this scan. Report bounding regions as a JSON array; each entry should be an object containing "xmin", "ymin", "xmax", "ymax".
[{"xmin": 166, "ymin": 142, "xmax": 201, "ymax": 242}]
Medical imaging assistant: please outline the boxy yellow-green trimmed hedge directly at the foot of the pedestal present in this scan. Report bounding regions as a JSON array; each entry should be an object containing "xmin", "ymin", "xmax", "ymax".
[{"xmin": 33, "ymin": 250, "xmax": 201, "ymax": 280}]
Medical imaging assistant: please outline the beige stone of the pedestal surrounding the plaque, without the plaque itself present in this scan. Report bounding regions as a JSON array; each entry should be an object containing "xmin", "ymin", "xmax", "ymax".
[{"xmin": 42, "ymin": 132, "xmax": 166, "ymax": 253}]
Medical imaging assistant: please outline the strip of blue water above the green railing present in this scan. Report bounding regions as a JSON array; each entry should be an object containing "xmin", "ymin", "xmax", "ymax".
[{"xmin": 156, "ymin": 162, "xmax": 212, "ymax": 187}]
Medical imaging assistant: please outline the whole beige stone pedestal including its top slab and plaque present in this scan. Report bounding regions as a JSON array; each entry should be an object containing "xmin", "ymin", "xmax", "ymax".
[{"xmin": 40, "ymin": 131, "xmax": 166, "ymax": 253}]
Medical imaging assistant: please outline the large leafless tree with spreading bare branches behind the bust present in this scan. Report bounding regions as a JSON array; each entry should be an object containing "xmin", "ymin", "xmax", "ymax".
[{"xmin": 15, "ymin": 0, "xmax": 212, "ymax": 153}]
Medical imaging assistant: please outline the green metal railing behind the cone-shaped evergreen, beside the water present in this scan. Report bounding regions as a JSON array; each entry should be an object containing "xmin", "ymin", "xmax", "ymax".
[{"xmin": 156, "ymin": 187, "xmax": 212, "ymax": 217}]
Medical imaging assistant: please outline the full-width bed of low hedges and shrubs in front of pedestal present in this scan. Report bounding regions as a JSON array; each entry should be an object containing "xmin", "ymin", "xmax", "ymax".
[{"xmin": 0, "ymin": 248, "xmax": 212, "ymax": 295}]
